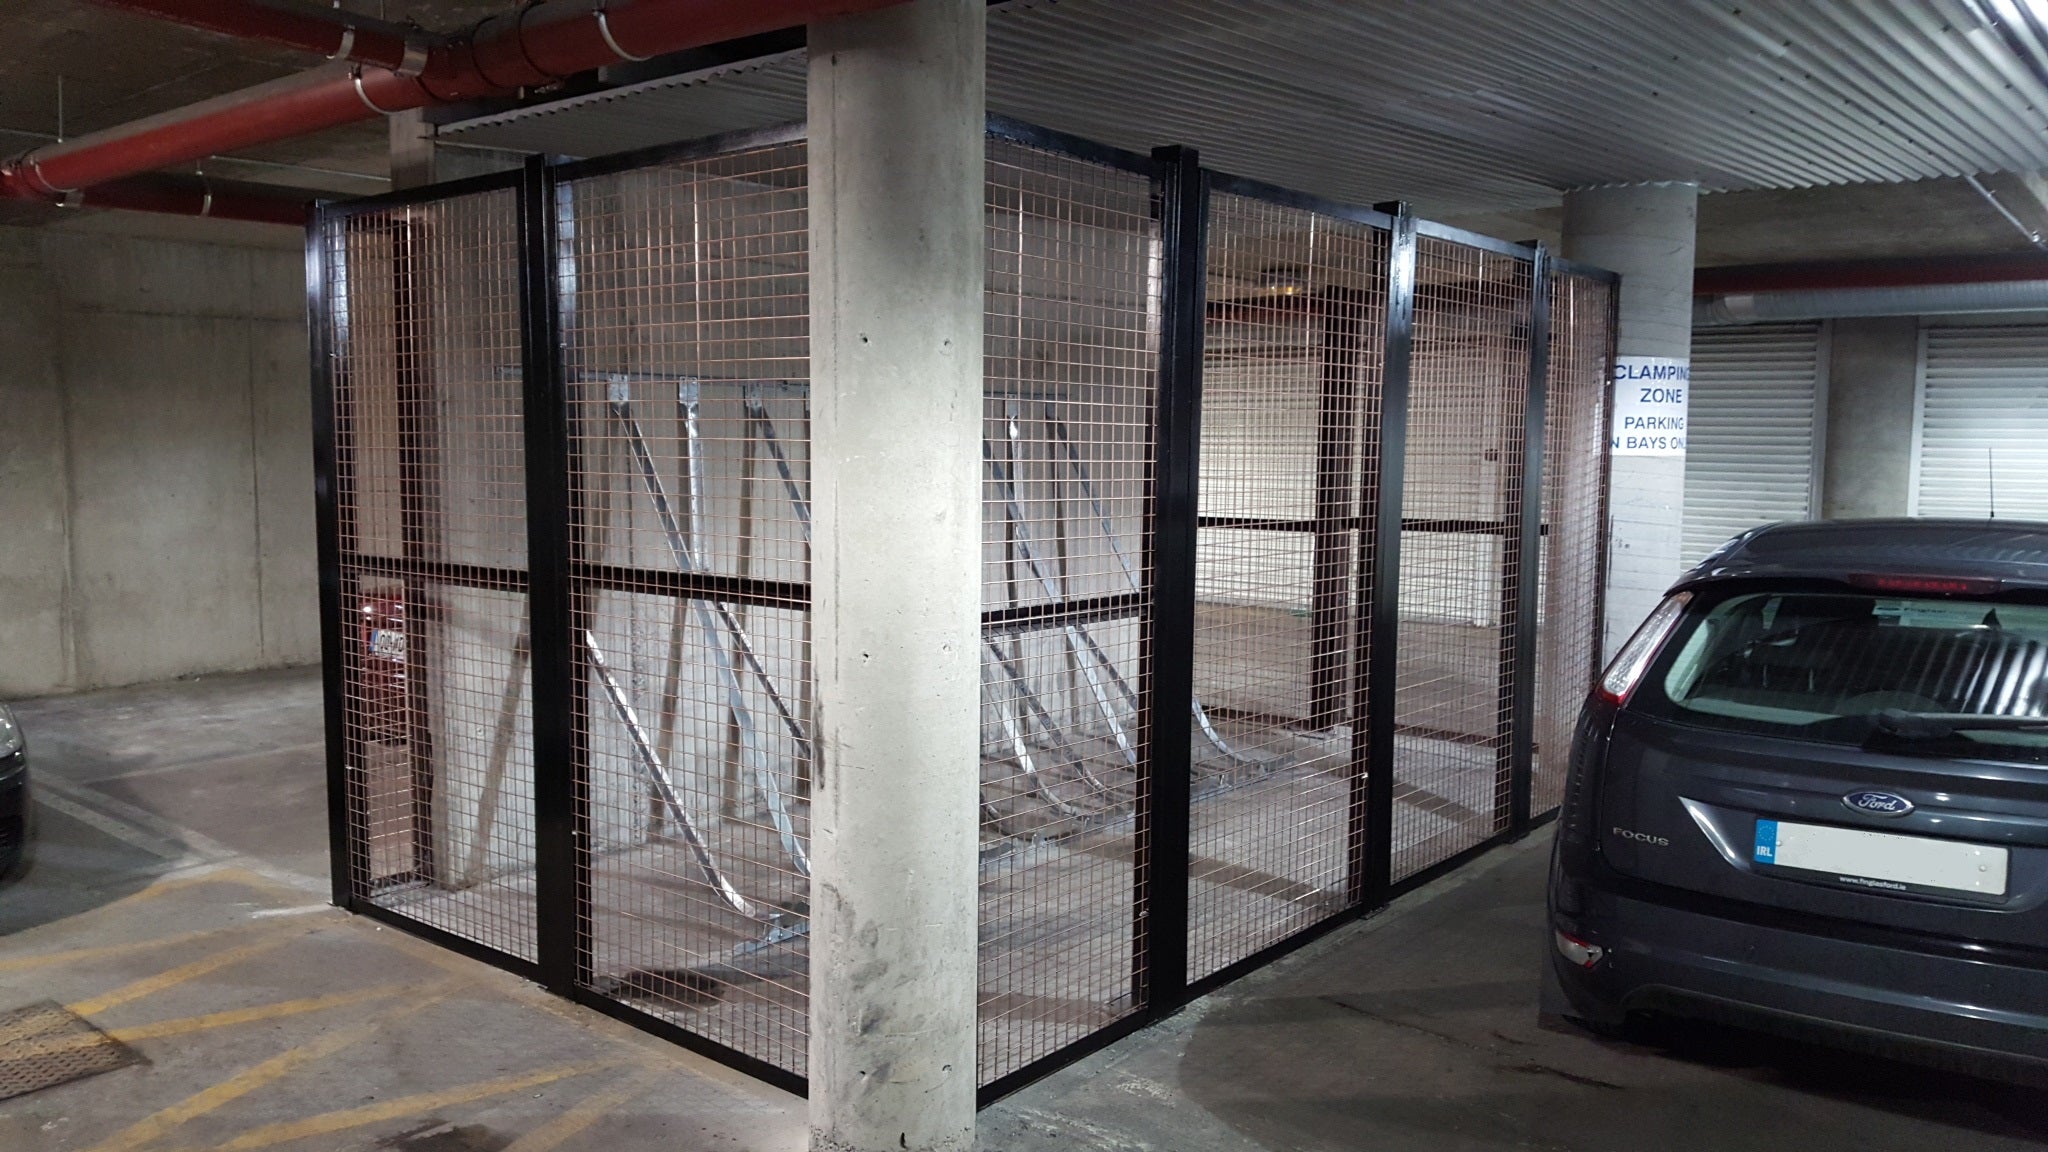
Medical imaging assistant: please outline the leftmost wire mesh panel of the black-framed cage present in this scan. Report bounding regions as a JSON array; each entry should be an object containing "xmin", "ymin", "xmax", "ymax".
[{"xmin": 322, "ymin": 189, "xmax": 535, "ymax": 959}]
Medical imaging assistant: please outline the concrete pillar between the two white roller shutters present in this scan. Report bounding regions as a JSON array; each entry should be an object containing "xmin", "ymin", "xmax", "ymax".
[{"xmin": 1821, "ymin": 316, "xmax": 1919, "ymax": 512}]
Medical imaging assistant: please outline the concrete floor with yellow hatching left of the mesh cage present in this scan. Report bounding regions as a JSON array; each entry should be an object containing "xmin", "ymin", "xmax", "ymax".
[{"xmin": 0, "ymin": 672, "xmax": 805, "ymax": 1152}]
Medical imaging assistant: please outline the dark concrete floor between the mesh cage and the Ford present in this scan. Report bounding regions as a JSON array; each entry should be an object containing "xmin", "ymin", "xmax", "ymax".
[{"xmin": 981, "ymin": 836, "xmax": 2048, "ymax": 1152}]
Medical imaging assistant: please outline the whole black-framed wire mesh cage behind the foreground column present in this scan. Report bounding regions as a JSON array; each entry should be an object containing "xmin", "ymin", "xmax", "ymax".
[{"xmin": 307, "ymin": 121, "xmax": 1614, "ymax": 1099}]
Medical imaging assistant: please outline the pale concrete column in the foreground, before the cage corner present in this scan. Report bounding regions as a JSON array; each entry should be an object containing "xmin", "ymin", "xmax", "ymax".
[{"xmin": 809, "ymin": 0, "xmax": 985, "ymax": 1152}]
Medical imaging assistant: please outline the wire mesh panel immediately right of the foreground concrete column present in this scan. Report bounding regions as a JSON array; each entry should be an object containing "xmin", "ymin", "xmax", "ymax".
[{"xmin": 979, "ymin": 139, "xmax": 1159, "ymax": 1082}]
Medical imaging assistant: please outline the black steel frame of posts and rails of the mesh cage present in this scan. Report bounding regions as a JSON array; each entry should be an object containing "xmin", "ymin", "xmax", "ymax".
[{"xmin": 305, "ymin": 117, "xmax": 1618, "ymax": 1105}]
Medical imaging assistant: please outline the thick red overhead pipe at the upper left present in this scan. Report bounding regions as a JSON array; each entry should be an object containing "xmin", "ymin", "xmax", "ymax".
[{"xmin": 0, "ymin": 0, "xmax": 899, "ymax": 199}]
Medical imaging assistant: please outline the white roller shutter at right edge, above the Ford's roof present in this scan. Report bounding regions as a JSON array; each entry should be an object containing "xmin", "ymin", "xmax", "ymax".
[{"xmin": 1913, "ymin": 326, "xmax": 2048, "ymax": 521}]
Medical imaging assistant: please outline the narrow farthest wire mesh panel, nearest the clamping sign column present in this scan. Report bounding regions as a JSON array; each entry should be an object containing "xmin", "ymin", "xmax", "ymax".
[{"xmin": 1530, "ymin": 275, "xmax": 1614, "ymax": 812}]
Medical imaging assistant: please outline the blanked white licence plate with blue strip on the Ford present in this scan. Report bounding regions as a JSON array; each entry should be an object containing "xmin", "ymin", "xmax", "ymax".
[{"xmin": 1751, "ymin": 820, "xmax": 2011, "ymax": 896}]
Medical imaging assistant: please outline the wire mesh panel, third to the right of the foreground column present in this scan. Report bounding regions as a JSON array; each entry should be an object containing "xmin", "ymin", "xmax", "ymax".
[{"xmin": 1391, "ymin": 236, "xmax": 1530, "ymax": 879}]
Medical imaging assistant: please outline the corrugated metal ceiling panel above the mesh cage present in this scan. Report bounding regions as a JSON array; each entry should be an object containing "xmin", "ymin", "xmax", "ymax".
[{"xmin": 451, "ymin": 0, "xmax": 2048, "ymax": 213}]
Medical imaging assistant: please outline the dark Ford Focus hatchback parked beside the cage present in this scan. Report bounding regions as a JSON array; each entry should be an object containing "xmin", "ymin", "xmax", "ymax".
[{"xmin": 1544, "ymin": 521, "xmax": 2048, "ymax": 1080}]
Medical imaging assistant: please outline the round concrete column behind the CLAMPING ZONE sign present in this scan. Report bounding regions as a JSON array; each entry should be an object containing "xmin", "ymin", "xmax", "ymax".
[{"xmin": 1563, "ymin": 184, "xmax": 1700, "ymax": 654}]
